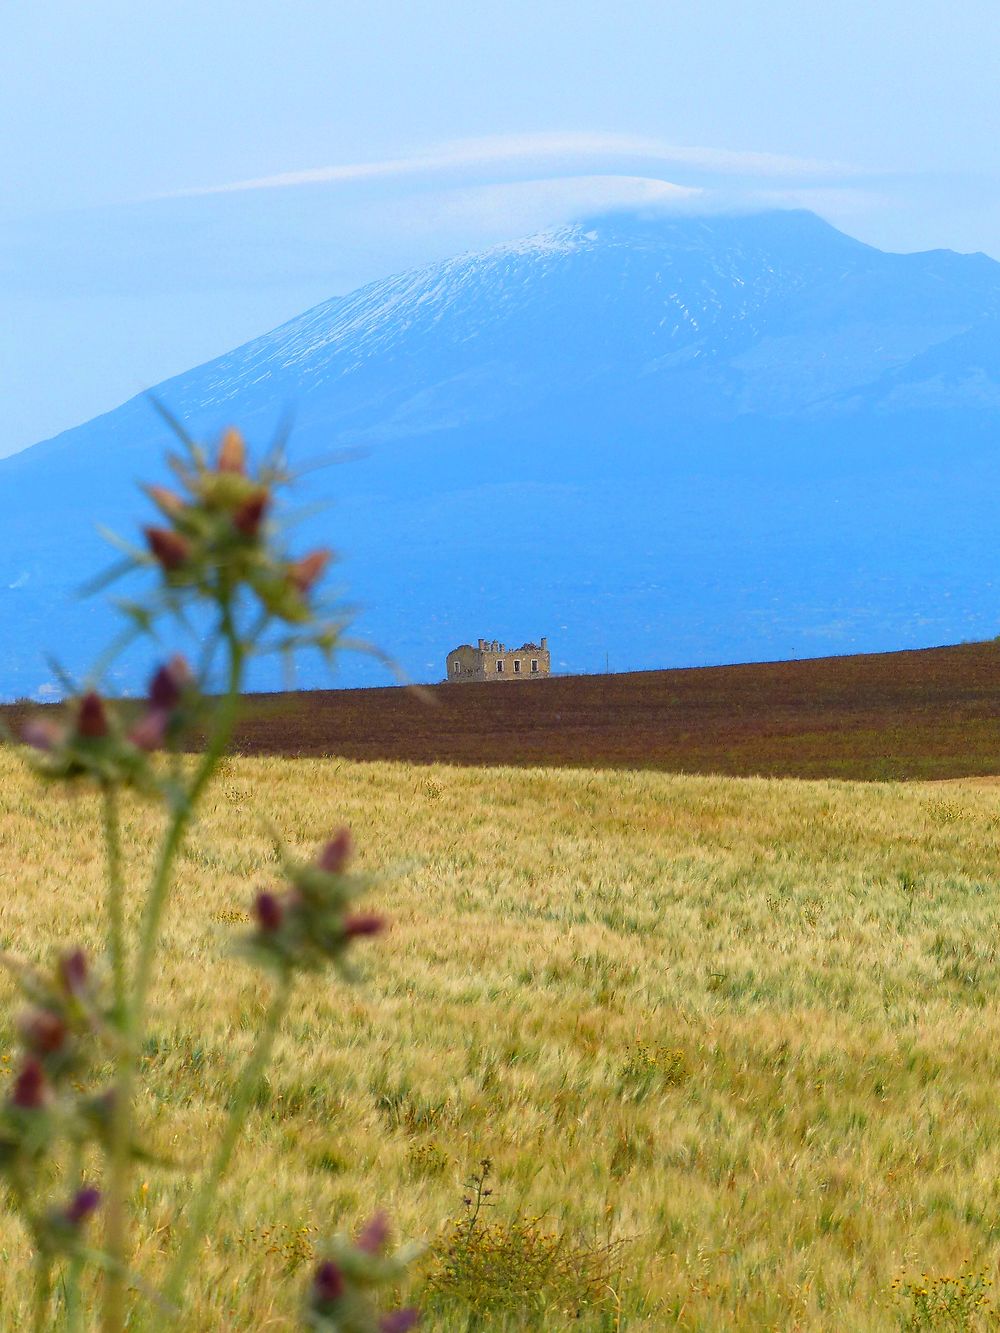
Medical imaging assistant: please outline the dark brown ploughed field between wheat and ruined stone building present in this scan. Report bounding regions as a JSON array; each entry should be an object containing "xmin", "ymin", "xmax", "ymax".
[{"xmin": 3, "ymin": 643, "xmax": 1000, "ymax": 780}]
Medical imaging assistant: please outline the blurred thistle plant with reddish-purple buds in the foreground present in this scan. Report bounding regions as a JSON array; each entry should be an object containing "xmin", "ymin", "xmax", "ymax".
[{"xmin": 0, "ymin": 429, "xmax": 416, "ymax": 1333}]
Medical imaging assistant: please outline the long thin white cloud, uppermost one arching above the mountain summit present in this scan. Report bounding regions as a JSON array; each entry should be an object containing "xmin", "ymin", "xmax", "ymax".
[{"xmin": 169, "ymin": 132, "xmax": 867, "ymax": 197}]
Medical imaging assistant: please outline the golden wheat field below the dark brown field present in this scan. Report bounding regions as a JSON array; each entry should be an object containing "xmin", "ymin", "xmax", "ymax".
[{"xmin": 0, "ymin": 750, "xmax": 1000, "ymax": 1330}]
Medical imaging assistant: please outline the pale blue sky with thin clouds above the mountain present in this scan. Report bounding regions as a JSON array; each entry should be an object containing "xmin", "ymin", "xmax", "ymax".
[{"xmin": 0, "ymin": 0, "xmax": 1000, "ymax": 456}]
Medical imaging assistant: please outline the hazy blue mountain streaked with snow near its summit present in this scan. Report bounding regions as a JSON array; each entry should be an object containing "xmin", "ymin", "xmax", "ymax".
[{"xmin": 0, "ymin": 212, "xmax": 1000, "ymax": 697}]
